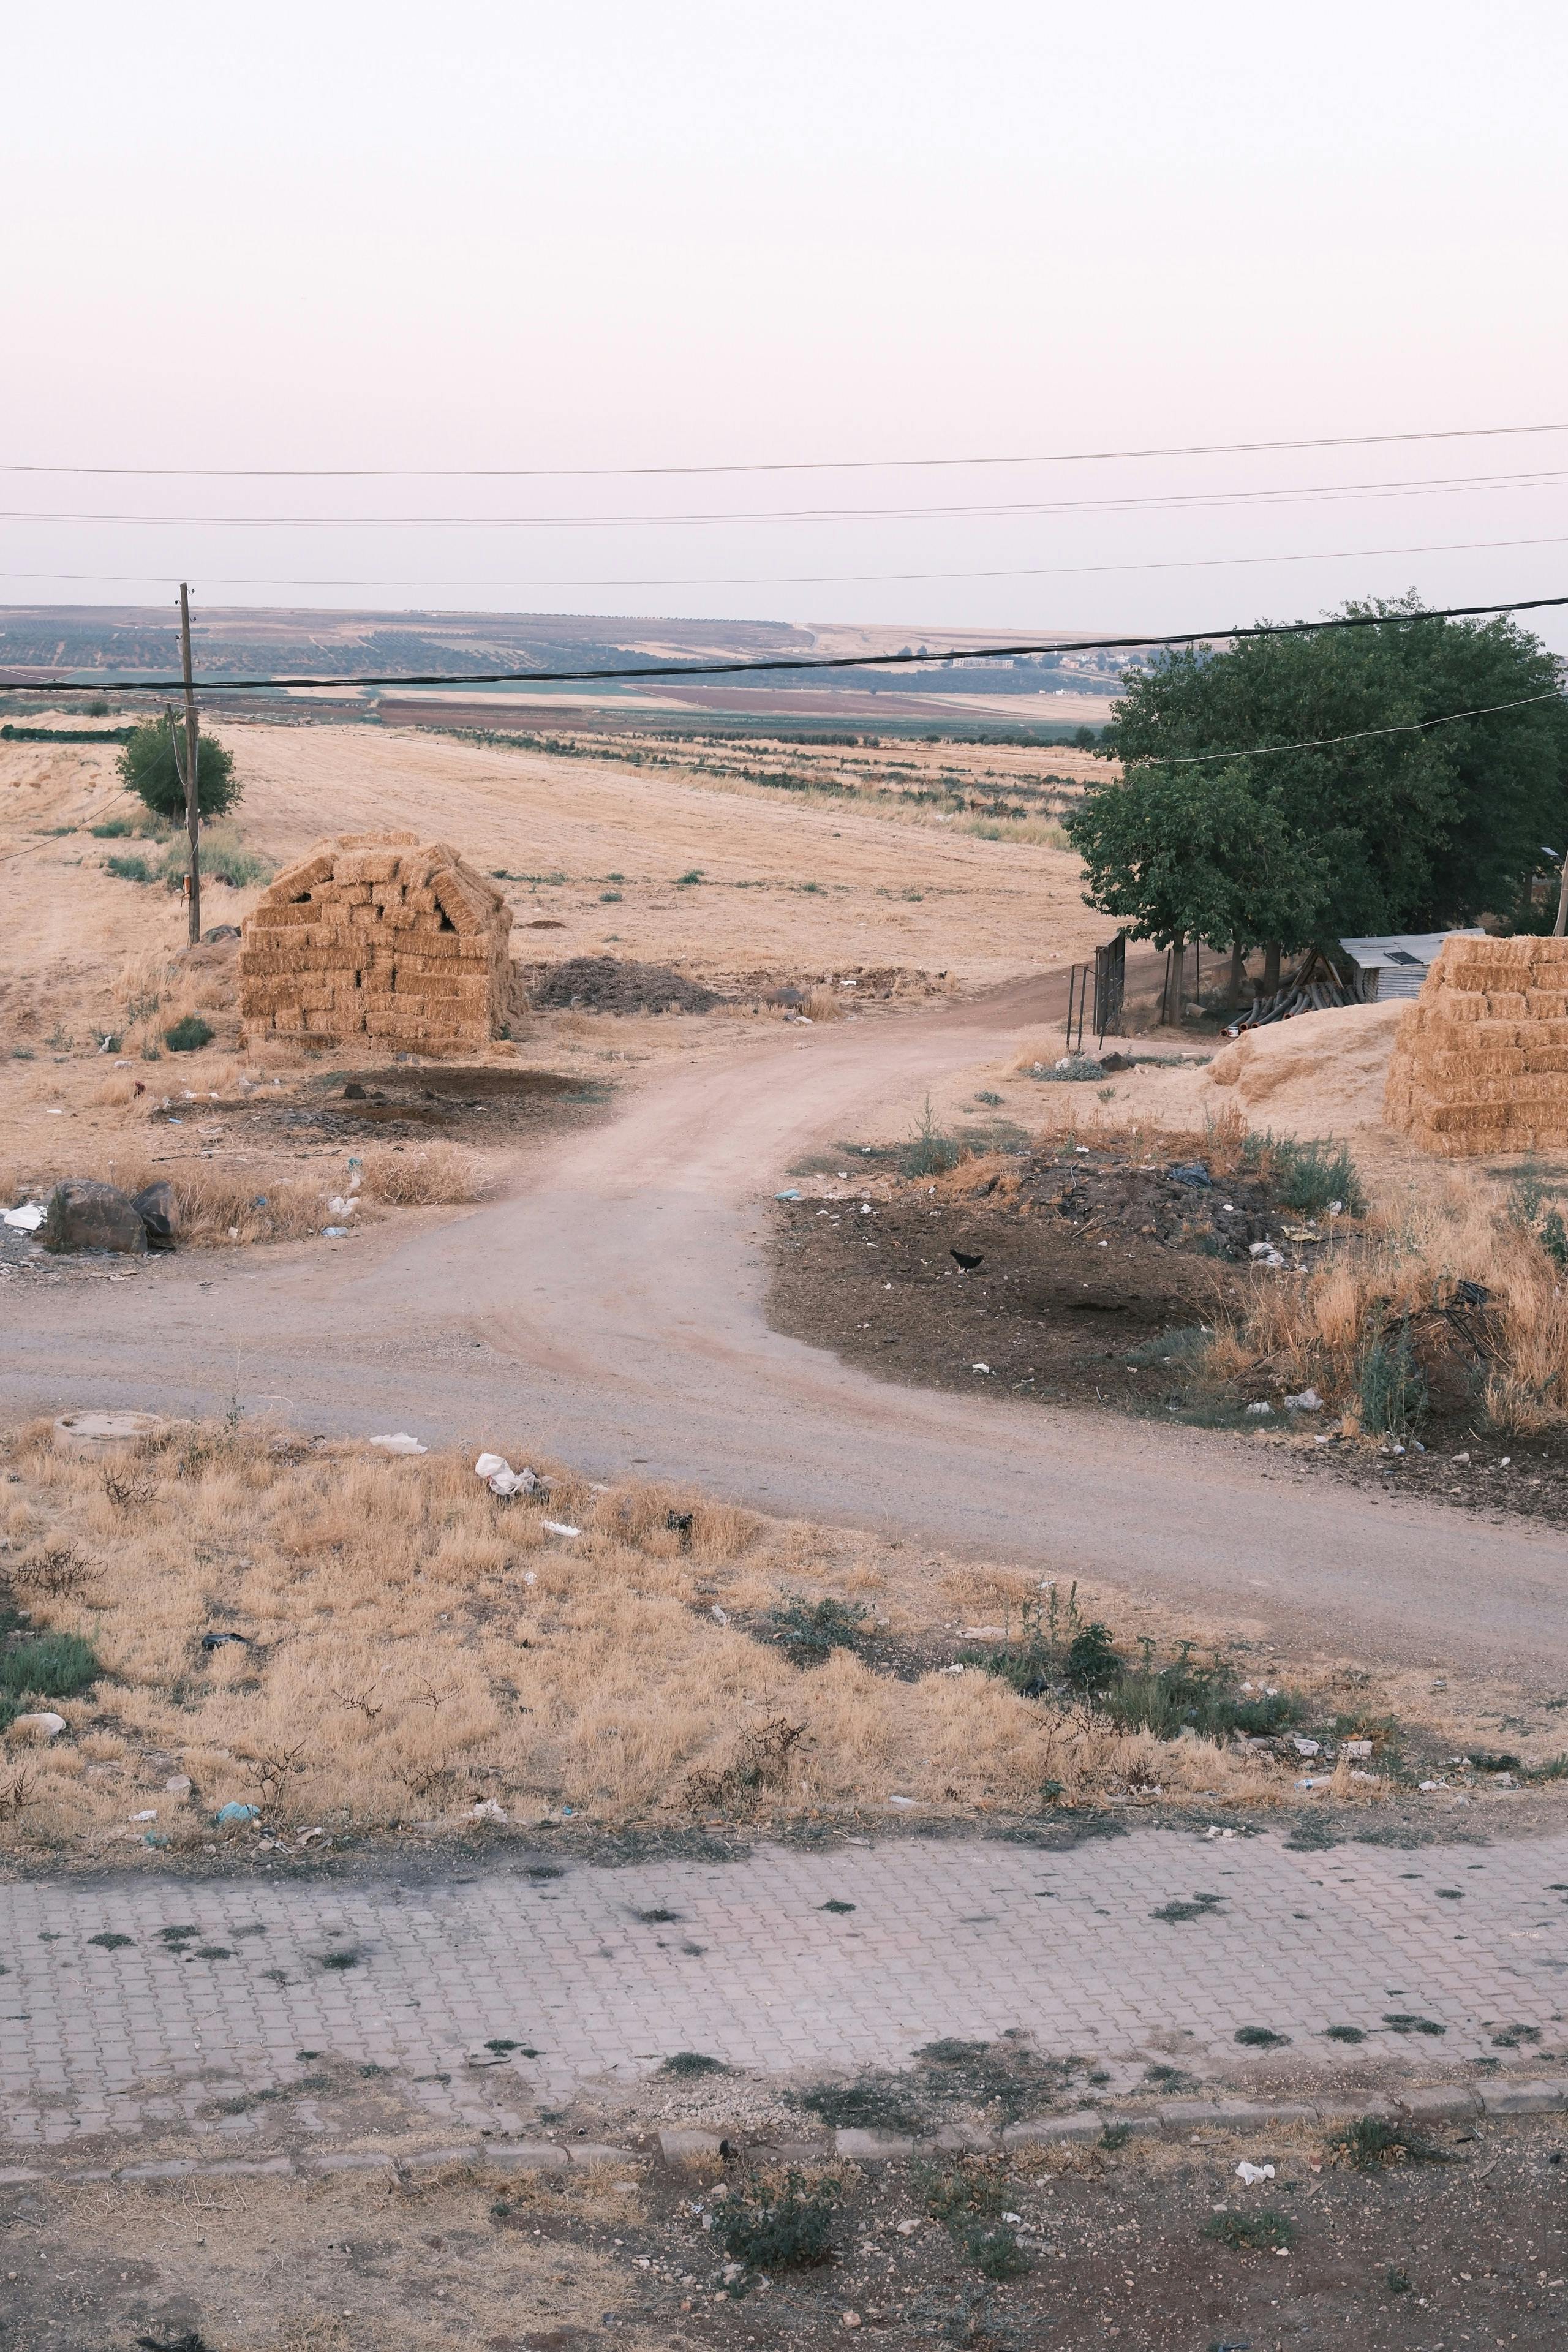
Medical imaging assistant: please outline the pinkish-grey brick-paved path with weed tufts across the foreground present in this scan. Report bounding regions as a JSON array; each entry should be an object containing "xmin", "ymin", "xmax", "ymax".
[{"xmin": 0, "ymin": 1830, "xmax": 1568, "ymax": 2157}]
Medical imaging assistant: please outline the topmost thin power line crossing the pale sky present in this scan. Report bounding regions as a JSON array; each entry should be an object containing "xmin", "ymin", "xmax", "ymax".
[{"xmin": 0, "ymin": 426, "xmax": 1568, "ymax": 482}]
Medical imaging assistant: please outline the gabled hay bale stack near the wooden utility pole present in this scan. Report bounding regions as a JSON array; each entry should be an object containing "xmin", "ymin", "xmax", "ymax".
[{"xmin": 239, "ymin": 832, "xmax": 513, "ymax": 1054}]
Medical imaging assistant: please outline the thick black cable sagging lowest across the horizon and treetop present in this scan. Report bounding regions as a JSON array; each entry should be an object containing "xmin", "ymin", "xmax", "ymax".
[{"xmin": 0, "ymin": 595, "xmax": 1568, "ymax": 691}]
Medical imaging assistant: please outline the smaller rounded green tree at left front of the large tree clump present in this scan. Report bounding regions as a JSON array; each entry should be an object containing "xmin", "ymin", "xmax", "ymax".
[{"xmin": 1067, "ymin": 760, "xmax": 1324, "ymax": 1019}]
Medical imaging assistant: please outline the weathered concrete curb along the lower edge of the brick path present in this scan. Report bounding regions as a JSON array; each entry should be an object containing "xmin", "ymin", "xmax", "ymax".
[{"xmin": 0, "ymin": 2081, "xmax": 1568, "ymax": 2190}]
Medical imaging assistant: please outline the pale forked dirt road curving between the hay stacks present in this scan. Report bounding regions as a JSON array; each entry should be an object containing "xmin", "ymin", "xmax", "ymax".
[{"xmin": 0, "ymin": 983, "xmax": 1568, "ymax": 1686}]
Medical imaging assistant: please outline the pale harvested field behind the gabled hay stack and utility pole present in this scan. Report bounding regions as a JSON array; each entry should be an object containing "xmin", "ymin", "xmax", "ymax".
[{"xmin": 0, "ymin": 713, "xmax": 1105, "ymax": 1213}]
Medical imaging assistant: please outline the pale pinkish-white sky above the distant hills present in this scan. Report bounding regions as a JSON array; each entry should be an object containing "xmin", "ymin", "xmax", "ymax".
[{"xmin": 0, "ymin": 0, "xmax": 1568, "ymax": 649}]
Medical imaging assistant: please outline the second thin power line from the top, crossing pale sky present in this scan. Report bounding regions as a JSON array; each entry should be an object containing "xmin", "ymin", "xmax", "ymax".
[{"xmin": 0, "ymin": 468, "xmax": 1568, "ymax": 532}]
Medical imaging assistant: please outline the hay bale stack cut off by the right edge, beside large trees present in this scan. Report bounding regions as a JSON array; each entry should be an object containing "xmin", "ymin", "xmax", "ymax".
[{"xmin": 1382, "ymin": 938, "xmax": 1568, "ymax": 1159}]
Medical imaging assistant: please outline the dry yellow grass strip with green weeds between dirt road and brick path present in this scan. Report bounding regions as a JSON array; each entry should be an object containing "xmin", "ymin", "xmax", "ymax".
[{"xmin": 0, "ymin": 1423, "xmax": 1551, "ymax": 1856}]
